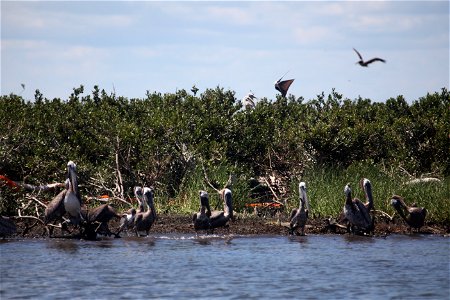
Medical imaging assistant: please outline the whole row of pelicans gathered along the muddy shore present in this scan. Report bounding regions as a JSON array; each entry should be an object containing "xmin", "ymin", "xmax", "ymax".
[{"xmin": 22, "ymin": 161, "xmax": 427, "ymax": 239}]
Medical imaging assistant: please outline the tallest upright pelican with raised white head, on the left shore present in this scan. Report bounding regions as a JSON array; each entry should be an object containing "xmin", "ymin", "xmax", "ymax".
[{"xmin": 64, "ymin": 161, "xmax": 83, "ymax": 225}]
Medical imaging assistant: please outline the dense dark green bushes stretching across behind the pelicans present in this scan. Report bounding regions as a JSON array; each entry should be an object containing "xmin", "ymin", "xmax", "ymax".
[{"xmin": 0, "ymin": 86, "xmax": 450, "ymax": 221}]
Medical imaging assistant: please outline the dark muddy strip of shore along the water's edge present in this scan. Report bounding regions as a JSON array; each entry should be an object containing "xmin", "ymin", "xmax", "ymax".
[{"xmin": 7, "ymin": 214, "xmax": 450, "ymax": 238}]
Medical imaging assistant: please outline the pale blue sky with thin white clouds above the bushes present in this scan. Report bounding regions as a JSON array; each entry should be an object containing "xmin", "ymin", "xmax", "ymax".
[{"xmin": 1, "ymin": 0, "xmax": 450, "ymax": 102}]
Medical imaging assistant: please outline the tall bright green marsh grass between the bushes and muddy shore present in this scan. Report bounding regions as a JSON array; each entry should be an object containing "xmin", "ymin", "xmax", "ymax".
[{"xmin": 159, "ymin": 162, "xmax": 450, "ymax": 223}]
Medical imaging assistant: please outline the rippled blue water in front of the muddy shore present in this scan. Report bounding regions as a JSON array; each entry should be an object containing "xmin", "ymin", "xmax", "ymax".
[{"xmin": 0, "ymin": 235, "xmax": 450, "ymax": 299}]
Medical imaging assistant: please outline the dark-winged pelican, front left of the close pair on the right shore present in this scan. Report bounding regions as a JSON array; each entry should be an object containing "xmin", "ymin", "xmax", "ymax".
[{"xmin": 344, "ymin": 183, "xmax": 373, "ymax": 233}]
